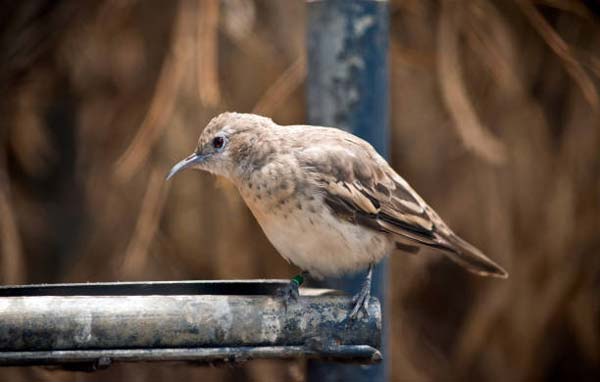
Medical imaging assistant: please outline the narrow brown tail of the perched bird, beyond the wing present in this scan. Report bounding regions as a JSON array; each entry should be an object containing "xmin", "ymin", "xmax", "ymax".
[{"xmin": 444, "ymin": 233, "xmax": 508, "ymax": 279}]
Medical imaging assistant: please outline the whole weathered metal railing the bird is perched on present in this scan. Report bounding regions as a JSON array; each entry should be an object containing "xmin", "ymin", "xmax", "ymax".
[{"xmin": 0, "ymin": 280, "xmax": 381, "ymax": 369}]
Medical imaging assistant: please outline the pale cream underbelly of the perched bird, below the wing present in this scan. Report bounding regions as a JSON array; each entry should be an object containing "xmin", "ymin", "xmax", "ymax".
[{"xmin": 253, "ymin": 206, "xmax": 394, "ymax": 278}]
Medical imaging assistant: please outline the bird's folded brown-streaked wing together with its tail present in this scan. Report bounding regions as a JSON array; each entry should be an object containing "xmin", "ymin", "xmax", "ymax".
[{"xmin": 297, "ymin": 132, "xmax": 508, "ymax": 278}]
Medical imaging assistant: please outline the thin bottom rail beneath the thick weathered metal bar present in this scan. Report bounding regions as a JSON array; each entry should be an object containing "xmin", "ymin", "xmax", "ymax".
[{"xmin": 0, "ymin": 345, "xmax": 381, "ymax": 370}]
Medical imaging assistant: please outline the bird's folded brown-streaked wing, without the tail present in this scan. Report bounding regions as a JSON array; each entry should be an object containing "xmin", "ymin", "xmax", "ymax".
[{"xmin": 301, "ymin": 141, "xmax": 447, "ymax": 249}]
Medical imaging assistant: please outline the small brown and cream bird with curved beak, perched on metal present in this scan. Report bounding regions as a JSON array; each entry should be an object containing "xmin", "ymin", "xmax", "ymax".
[{"xmin": 166, "ymin": 112, "xmax": 508, "ymax": 319}]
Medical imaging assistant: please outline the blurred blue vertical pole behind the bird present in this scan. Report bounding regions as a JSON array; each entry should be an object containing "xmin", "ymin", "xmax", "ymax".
[{"xmin": 307, "ymin": 0, "xmax": 390, "ymax": 382}]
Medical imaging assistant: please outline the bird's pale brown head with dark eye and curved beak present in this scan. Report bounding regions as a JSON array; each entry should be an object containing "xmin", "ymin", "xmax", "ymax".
[{"xmin": 167, "ymin": 113, "xmax": 274, "ymax": 180}]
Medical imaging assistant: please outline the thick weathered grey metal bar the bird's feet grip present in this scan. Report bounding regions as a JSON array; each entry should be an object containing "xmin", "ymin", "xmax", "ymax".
[{"xmin": 0, "ymin": 295, "xmax": 380, "ymax": 351}]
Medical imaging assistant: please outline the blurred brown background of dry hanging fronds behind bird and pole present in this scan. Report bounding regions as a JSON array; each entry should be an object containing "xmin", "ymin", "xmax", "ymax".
[{"xmin": 0, "ymin": 0, "xmax": 600, "ymax": 382}]
